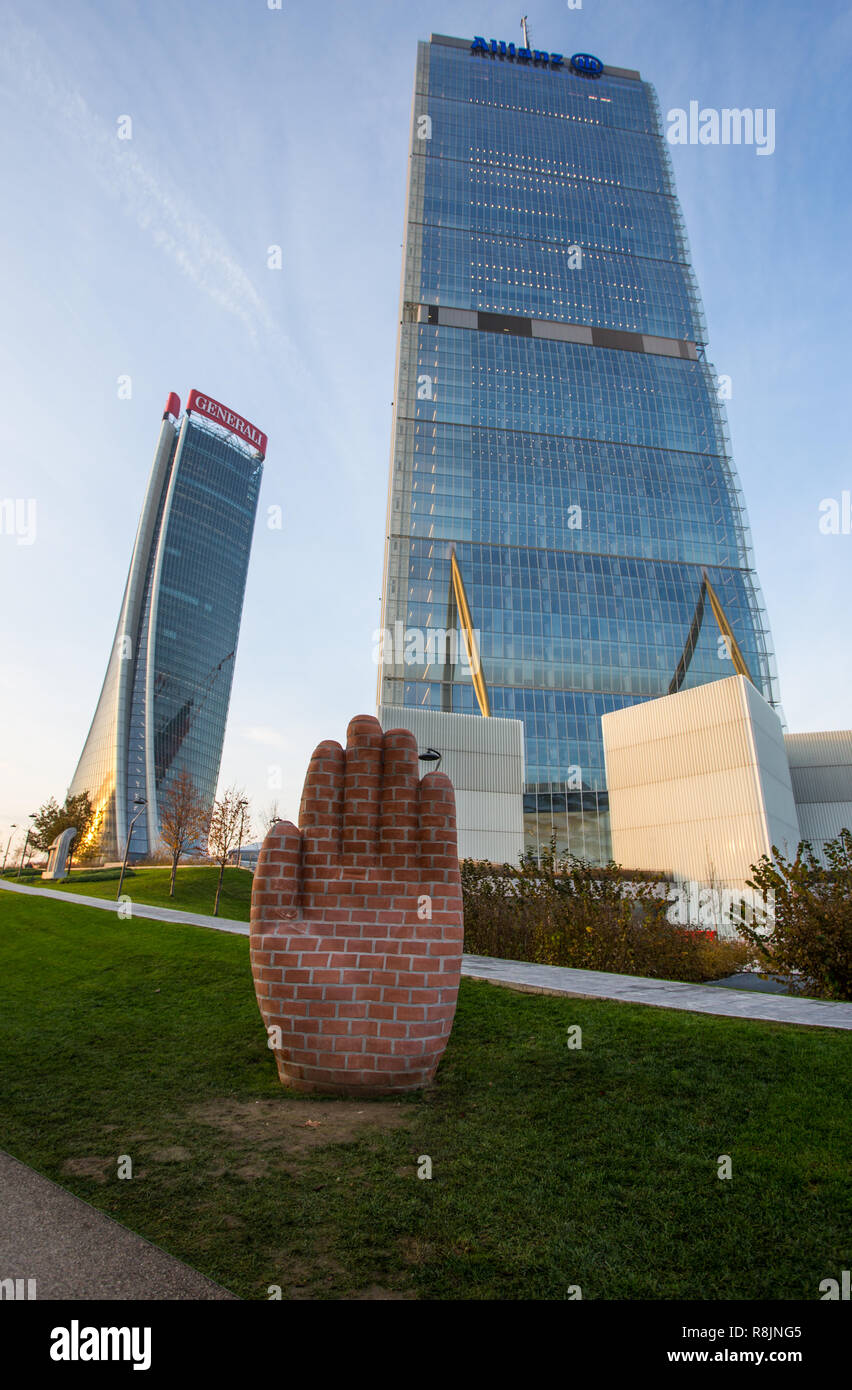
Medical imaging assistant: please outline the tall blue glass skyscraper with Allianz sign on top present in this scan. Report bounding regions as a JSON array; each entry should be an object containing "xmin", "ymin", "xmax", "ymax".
[{"xmin": 379, "ymin": 35, "xmax": 778, "ymax": 862}]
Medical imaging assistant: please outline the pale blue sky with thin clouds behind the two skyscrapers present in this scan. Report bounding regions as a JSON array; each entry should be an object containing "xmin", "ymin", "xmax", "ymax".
[{"xmin": 0, "ymin": 0, "xmax": 852, "ymax": 838}]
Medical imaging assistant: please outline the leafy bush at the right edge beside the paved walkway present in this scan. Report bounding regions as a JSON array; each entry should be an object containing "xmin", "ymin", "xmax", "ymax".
[{"xmin": 738, "ymin": 830, "xmax": 852, "ymax": 999}]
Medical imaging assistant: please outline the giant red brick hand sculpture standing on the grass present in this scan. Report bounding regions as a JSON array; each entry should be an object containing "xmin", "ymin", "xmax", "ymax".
[{"xmin": 252, "ymin": 714, "xmax": 463, "ymax": 1095}]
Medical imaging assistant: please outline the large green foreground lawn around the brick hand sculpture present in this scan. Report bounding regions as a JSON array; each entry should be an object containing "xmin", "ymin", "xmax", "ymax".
[{"xmin": 0, "ymin": 895, "xmax": 852, "ymax": 1300}]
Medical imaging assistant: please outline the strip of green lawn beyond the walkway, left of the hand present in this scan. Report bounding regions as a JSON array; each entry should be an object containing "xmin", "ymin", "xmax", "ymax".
[{"xmin": 20, "ymin": 865, "xmax": 252, "ymax": 922}]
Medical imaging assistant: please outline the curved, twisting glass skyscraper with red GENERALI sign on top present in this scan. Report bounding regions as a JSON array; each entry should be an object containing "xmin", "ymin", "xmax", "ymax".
[{"xmin": 69, "ymin": 391, "xmax": 267, "ymax": 858}]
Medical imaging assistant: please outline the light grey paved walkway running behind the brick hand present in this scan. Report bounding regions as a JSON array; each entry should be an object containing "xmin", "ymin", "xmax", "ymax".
[{"xmin": 0, "ymin": 880, "xmax": 852, "ymax": 1029}]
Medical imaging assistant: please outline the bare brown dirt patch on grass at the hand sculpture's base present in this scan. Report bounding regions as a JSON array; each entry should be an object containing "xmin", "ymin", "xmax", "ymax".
[{"xmin": 189, "ymin": 1097, "xmax": 417, "ymax": 1156}]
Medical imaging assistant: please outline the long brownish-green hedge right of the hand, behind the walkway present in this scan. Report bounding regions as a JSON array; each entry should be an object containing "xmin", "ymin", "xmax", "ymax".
[{"xmin": 461, "ymin": 848, "xmax": 753, "ymax": 981}]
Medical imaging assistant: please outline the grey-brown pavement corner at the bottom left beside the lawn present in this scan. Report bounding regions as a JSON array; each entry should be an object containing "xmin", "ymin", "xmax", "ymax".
[{"xmin": 0, "ymin": 1150, "xmax": 236, "ymax": 1301}]
